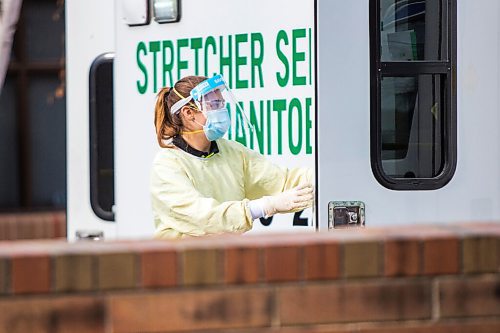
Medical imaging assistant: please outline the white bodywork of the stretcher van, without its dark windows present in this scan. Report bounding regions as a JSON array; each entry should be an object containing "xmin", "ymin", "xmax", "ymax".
[{"xmin": 66, "ymin": 0, "xmax": 500, "ymax": 239}]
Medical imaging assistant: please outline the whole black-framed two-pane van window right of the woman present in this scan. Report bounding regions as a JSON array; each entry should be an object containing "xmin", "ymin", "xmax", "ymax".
[{"xmin": 370, "ymin": 0, "xmax": 456, "ymax": 190}]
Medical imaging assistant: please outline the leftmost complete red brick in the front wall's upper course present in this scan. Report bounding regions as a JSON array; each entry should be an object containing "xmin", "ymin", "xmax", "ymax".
[{"xmin": 11, "ymin": 255, "xmax": 50, "ymax": 294}]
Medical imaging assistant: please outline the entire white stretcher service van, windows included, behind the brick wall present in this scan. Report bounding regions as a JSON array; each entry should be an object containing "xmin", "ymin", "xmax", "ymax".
[{"xmin": 66, "ymin": 0, "xmax": 500, "ymax": 239}]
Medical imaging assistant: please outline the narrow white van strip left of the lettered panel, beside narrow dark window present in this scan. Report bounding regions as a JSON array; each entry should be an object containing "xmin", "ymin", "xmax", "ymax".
[{"xmin": 66, "ymin": 0, "xmax": 116, "ymax": 240}]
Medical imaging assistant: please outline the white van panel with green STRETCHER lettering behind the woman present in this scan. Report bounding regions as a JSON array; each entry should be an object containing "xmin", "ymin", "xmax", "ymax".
[{"xmin": 115, "ymin": 0, "xmax": 314, "ymax": 237}]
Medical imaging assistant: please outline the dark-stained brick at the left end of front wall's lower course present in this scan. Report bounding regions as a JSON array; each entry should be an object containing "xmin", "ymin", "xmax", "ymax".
[{"xmin": 0, "ymin": 296, "xmax": 106, "ymax": 333}]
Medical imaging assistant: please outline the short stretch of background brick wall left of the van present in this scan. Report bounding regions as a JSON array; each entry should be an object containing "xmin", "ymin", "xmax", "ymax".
[{"xmin": 0, "ymin": 211, "xmax": 66, "ymax": 240}]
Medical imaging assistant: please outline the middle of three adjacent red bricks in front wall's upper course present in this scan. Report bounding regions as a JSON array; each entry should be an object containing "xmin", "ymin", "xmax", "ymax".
[{"xmin": 264, "ymin": 246, "xmax": 301, "ymax": 282}]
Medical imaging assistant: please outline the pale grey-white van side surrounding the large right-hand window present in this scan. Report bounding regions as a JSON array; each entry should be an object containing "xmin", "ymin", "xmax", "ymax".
[{"xmin": 317, "ymin": 0, "xmax": 500, "ymax": 229}]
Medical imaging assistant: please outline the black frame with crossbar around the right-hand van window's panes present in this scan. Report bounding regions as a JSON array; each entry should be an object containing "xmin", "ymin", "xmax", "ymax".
[{"xmin": 369, "ymin": 0, "xmax": 457, "ymax": 190}]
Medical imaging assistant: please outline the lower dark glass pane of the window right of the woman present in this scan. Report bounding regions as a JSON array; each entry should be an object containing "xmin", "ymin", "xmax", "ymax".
[{"xmin": 380, "ymin": 75, "xmax": 446, "ymax": 178}]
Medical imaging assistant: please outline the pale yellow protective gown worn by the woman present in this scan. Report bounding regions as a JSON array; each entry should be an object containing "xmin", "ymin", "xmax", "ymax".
[{"xmin": 151, "ymin": 139, "xmax": 312, "ymax": 238}]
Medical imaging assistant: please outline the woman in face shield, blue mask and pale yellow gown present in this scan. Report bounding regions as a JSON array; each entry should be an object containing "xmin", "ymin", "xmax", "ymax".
[{"xmin": 151, "ymin": 75, "xmax": 313, "ymax": 238}]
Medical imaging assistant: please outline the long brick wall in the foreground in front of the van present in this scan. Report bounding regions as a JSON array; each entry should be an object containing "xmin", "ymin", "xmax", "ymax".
[{"xmin": 0, "ymin": 223, "xmax": 500, "ymax": 333}]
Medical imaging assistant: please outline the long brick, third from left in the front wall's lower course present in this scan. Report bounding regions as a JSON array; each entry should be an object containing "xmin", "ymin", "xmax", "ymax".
[{"xmin": 278, "ymin": 280, "xmax": 431, "ymax": 325}]
